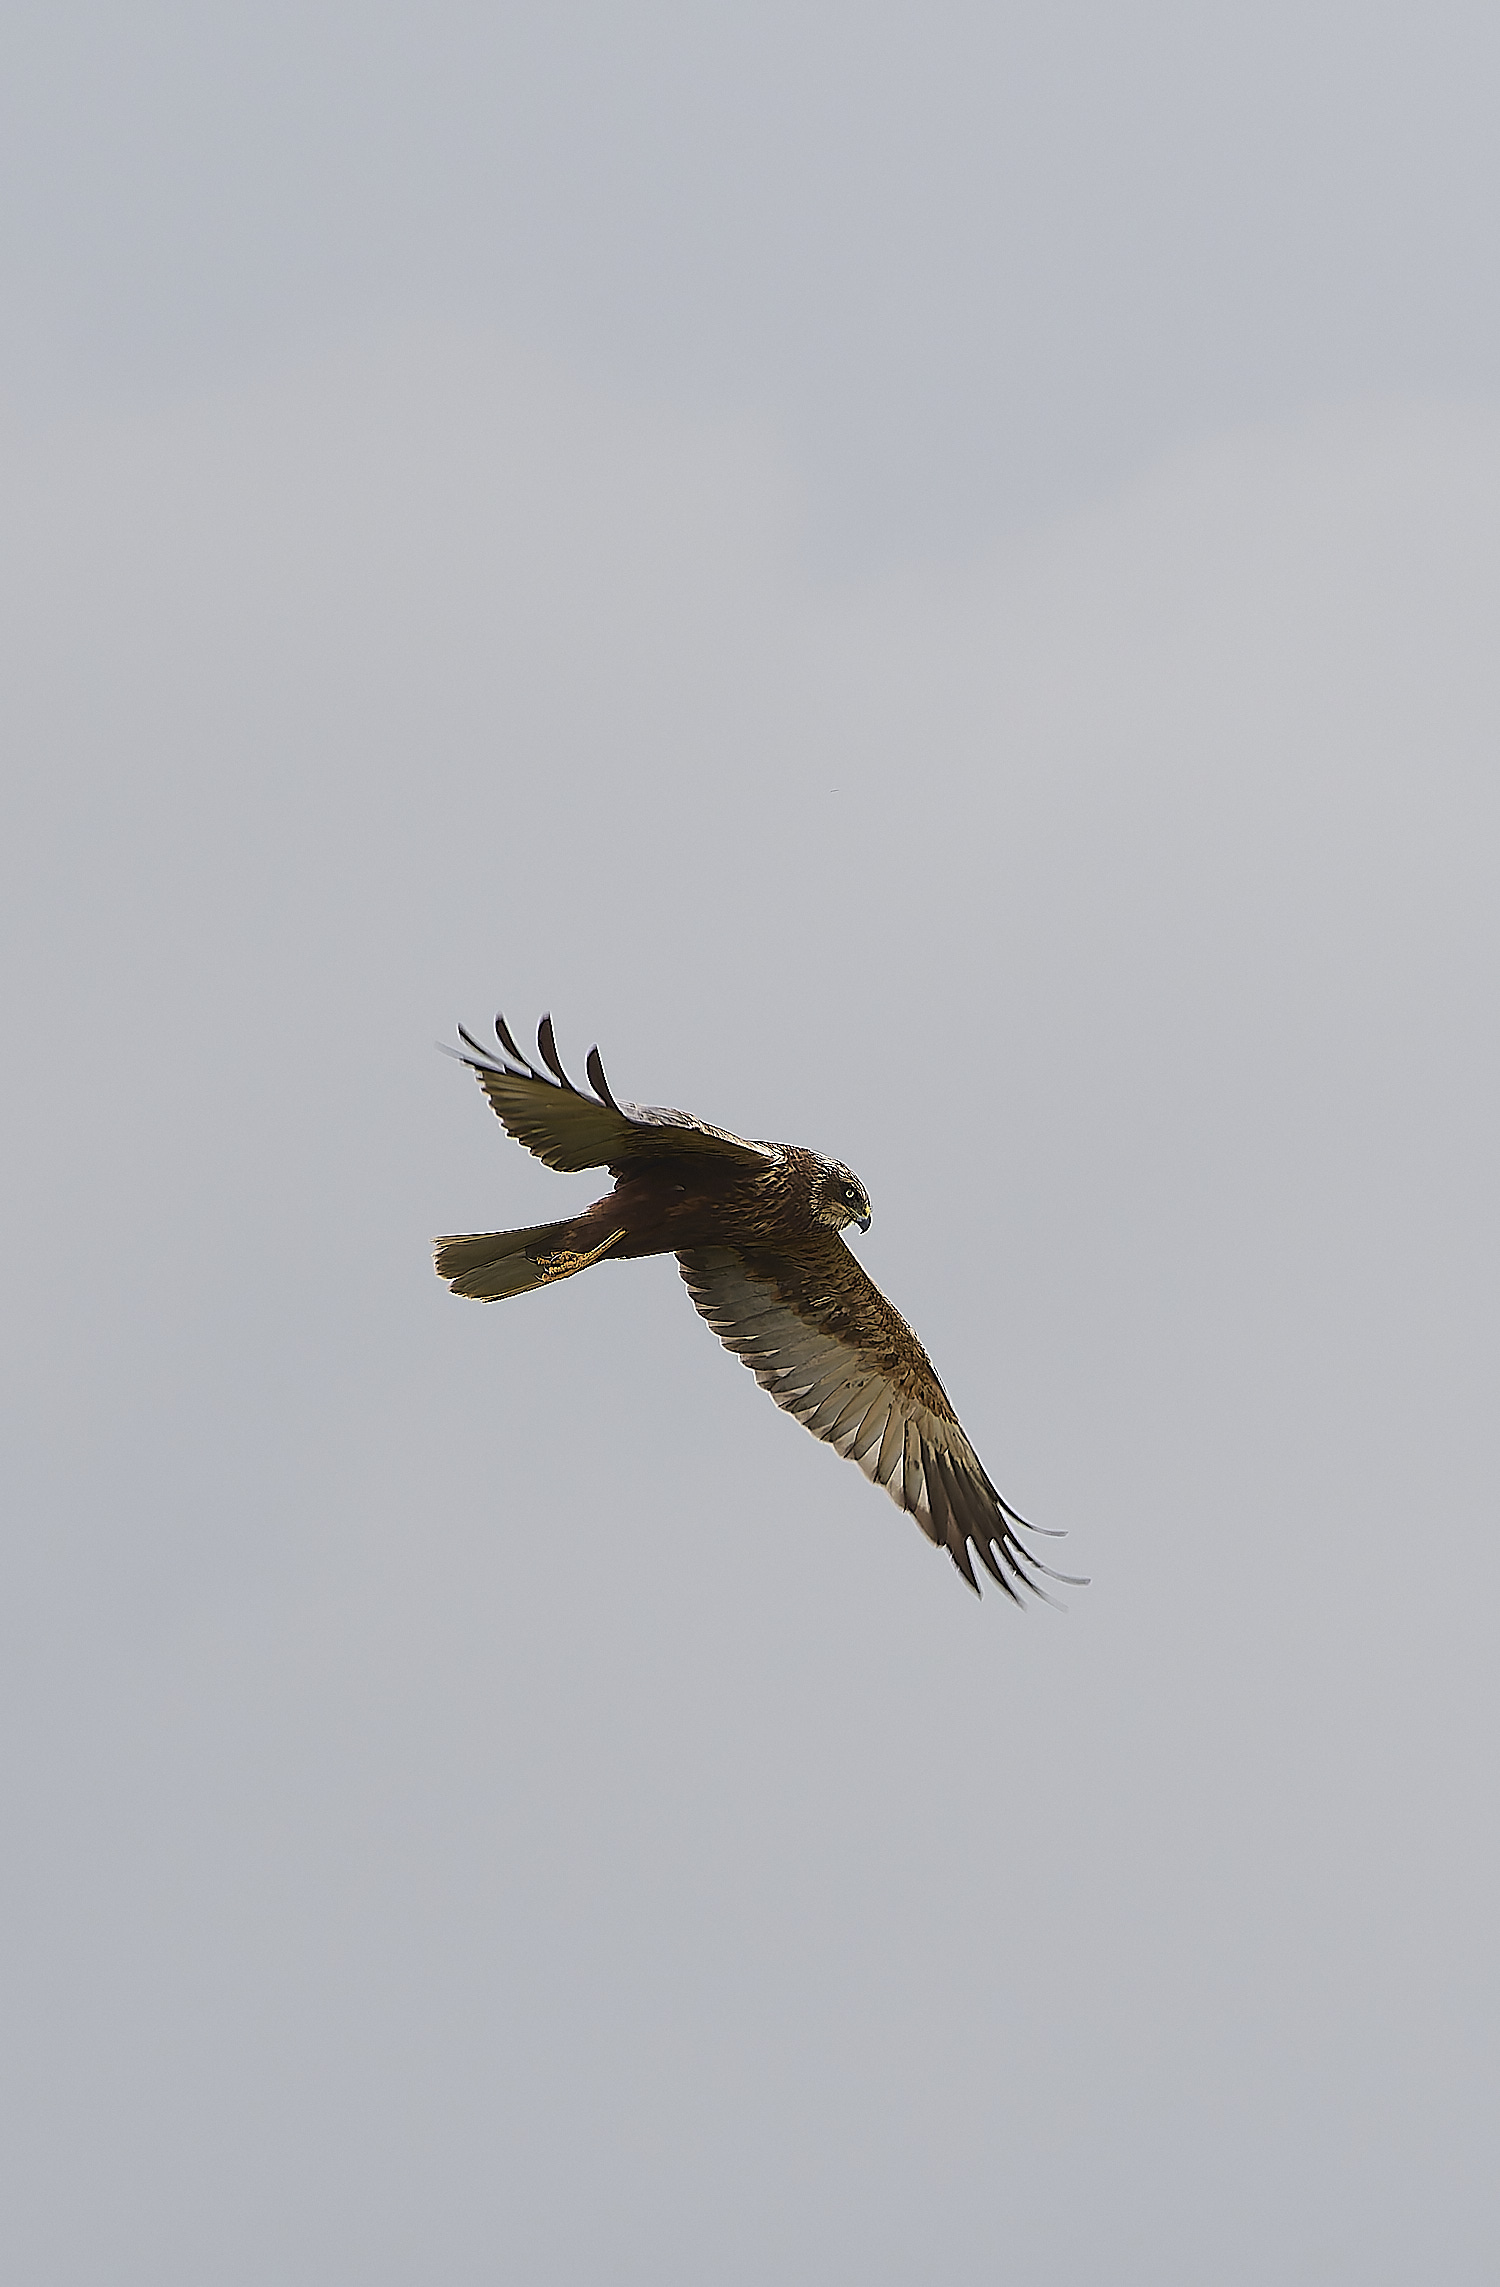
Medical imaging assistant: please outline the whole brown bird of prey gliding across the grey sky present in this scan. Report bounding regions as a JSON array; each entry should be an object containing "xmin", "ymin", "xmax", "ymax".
[{"xmin": 434, "ymin": 1015, "xmax": 1068, "ymax": 1603}]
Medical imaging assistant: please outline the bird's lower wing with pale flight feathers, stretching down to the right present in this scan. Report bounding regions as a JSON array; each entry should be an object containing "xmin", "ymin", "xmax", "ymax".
[{"xmin": 677, "ymin": 1235, "xmax": 1066, "ymax": 1603}]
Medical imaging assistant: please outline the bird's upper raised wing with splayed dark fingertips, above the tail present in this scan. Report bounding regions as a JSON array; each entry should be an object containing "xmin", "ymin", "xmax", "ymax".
[{"xmin": 450, "ymin": 1015, "xmax": 777, "ymax": 1173}]
